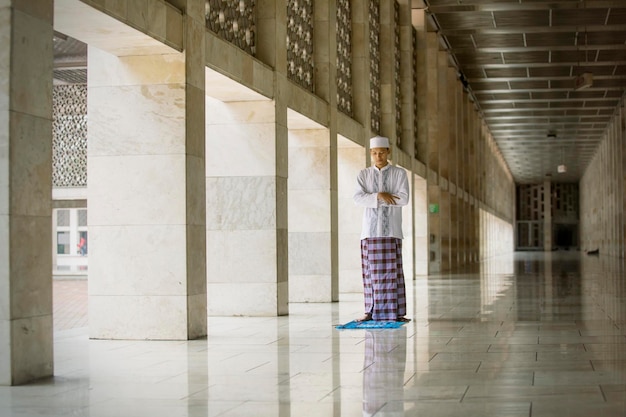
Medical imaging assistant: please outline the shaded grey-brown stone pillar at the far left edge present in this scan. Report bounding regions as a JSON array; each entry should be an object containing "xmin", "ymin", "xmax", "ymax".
[{"xmin": 0, "ymin": 0, "xmax": 54, "ymax": 385}]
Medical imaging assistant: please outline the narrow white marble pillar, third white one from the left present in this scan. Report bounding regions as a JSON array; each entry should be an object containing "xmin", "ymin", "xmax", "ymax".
[{"xmin": 288, "ymin": 129, "xmax": 333, "ymax": 302}]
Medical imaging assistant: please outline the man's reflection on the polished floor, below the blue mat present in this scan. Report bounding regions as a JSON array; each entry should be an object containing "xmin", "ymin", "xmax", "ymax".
[{"xmin": 363, "ymin": 328, "xmax": 406, "ymax": 417}]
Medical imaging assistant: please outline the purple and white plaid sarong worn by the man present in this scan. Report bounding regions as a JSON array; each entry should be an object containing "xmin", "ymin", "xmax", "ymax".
[{"xmin": 361, "ymin": 237, "xmax": 406, "ymax": 320}]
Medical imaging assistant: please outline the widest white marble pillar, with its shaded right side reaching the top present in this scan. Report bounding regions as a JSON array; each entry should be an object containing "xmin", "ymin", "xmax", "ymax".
[{"xmin": 87, "ymin": 0, "xmax": 207, "ymax": 340}]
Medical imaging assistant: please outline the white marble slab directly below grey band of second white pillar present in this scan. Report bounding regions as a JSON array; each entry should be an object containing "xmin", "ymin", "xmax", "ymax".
[{"xmin": 207, "ymin": 230, "xmax": 278, "ymax": 282}]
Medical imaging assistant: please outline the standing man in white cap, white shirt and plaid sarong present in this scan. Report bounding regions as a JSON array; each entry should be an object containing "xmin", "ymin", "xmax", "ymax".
[{"xmin": 354, "ymin": 136, "xmax": 410, "ymax": 321}]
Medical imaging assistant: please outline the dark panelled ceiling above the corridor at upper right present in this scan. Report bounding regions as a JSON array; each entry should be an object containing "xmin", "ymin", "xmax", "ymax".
[{"xmin": 412, "ymin": 0, "xmax": 626, "ymax": 183}]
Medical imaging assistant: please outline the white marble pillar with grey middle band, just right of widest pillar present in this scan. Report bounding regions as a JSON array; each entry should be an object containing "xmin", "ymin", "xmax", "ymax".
[{"xmin": 206, "ymin": 96, "xmax": 288, "ymax": 316}]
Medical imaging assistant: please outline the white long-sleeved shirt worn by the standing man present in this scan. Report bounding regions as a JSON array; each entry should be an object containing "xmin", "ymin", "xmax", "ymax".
[{"xmin": 353, "ymin": 164, "xmax": 409, "ymax": 239}]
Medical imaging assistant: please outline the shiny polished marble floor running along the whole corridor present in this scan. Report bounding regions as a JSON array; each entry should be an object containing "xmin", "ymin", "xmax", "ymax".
[{"xmin": 0, "ymin": 252, "xmax": 626, "ymax": 417}]
